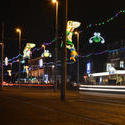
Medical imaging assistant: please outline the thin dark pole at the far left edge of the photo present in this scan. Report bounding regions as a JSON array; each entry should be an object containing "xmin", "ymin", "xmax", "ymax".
[{"xmin": 0, "ymin": 23, "xmax": 4, "ymax": 88}]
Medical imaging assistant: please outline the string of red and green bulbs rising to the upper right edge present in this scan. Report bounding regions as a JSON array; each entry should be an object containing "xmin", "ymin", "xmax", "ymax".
[{"xmin": 86, "ymin": 10, "xmax": 125, "ymax": 29}]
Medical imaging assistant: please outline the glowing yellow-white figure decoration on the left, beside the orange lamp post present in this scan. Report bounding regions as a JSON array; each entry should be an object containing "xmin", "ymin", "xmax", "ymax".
[{"xmin": 23, "ymin": 43, "xmax": 36, "ymax": 59}]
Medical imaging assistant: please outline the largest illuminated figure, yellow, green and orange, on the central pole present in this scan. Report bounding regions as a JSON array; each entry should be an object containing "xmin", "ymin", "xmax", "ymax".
[{"xmin": 66, "ymin": 21, "xmax": 81, "ymax": 62}]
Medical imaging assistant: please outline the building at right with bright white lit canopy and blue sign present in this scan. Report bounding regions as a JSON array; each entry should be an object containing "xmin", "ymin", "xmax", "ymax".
[{"xmin": 85, "ymin": 40, "xmax": 125, "ymax": 85}]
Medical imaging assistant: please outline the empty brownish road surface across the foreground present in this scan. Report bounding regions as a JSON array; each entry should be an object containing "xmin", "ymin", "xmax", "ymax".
[{"xmin": 0, "ymin": 87, "xmax": 125, "ymax": 125}]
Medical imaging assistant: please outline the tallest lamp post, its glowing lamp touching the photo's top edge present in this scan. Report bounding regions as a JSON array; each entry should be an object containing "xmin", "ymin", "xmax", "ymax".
[{"xmin": 52, "ymin": 0, "xmax": 58, "ymax": 90}]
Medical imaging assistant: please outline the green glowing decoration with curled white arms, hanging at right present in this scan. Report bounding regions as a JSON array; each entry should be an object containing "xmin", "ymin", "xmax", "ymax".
[{"xmin": 89, "ymin": 32, "xmax": 105, "ymax": 44}]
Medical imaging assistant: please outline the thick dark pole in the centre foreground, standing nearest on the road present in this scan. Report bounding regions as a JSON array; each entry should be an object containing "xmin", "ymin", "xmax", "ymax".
[{"xmin": 61, "ymin": 0, "xmax": 68, "ymax": 101}]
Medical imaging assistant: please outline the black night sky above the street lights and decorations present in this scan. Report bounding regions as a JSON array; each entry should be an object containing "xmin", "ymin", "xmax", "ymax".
[{"xmin": 0, "ymin": 0, "xmax": 125, "ymax": 57}]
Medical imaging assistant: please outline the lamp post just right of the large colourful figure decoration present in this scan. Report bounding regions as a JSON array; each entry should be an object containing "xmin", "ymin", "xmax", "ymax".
[{"xmin": 75, "ymin": 31, "xmax": 79, "ymax": 84}]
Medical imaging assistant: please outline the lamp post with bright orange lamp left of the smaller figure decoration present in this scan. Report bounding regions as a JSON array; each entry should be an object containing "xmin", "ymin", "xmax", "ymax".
[{"xmin": 16, "ymin": 28, "xmax": 21, "ymax": 87}]
